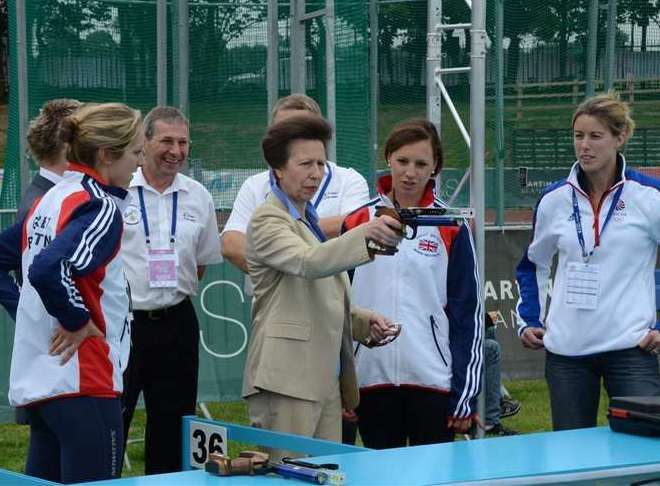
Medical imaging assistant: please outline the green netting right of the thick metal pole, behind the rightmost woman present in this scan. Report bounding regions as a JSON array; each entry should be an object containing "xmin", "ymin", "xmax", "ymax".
[{"xmin": 487, "ymin": 0, "xmax": 660, "ymax": 221}]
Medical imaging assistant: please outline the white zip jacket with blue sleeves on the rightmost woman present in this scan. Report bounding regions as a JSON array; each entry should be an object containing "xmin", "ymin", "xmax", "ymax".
[{"xmin": 517, "ymin": 156, "xmax": 660, "ymax": 356}]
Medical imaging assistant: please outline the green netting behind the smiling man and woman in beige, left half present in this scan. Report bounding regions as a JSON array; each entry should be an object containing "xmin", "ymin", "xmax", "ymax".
[{"xmin": 2, "ymin": 0, "xmax": 371, "ymax": 211}]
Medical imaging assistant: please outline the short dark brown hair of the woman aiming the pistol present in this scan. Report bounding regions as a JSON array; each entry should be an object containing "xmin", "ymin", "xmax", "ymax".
[{"xmin": 261, "ymin": 113, "xmax": 332, "ymax": 169}]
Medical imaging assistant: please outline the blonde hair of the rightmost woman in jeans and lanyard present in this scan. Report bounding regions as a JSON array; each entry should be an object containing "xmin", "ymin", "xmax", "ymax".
[{"xmin": 572, "ymin": 91, "xmax": 635, "ymax": 143}]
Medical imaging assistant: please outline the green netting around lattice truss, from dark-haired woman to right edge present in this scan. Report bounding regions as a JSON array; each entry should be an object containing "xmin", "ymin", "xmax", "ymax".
[{"xmin": 378, "ymin": 0, "xmax": 660, "ymax": 222}]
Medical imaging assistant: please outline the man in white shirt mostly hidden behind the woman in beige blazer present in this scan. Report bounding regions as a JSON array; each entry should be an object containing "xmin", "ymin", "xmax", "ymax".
[{"xmin": 222, "ymin": 94, "xmax": 369, "ymax": 272}]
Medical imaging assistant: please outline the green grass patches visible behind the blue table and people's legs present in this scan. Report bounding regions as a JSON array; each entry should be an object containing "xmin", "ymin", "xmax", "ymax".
[{"xmin": 0, "ymin": 380, "xmax": 607, "ymax": 477}]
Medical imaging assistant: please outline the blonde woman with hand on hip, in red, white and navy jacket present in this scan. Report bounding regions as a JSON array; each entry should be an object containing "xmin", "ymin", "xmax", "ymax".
[{"xmin": 0, "ymin": 103, "xmax": 143, "ymax": 483}]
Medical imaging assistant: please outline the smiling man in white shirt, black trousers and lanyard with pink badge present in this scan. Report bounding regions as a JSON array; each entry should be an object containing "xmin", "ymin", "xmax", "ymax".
[{"xmin": 122, "ymin": 107, "xmax": 222, "ymax": 474}]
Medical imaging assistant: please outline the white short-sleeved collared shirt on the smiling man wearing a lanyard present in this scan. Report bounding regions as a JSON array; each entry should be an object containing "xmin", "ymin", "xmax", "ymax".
[{"xmin": 122, "ymin": 168, "xmax": 222, "ymax": 310}]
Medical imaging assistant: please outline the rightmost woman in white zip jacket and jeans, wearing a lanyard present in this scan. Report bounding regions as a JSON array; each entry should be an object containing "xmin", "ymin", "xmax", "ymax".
[{"xmin": 517, "ymin": 94, "xmax": 660, "ymax": 430}]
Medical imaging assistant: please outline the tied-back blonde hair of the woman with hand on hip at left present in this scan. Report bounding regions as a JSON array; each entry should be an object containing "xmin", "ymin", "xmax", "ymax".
[{"xmin": 60, "ymin": 103, "xmax": 142, "ymax": 167}]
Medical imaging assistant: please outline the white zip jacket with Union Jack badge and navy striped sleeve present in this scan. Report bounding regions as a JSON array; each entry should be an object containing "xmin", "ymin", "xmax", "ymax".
[{"xmin": 344, "ymin": 176, "xmax": 483, "ymax": 417}]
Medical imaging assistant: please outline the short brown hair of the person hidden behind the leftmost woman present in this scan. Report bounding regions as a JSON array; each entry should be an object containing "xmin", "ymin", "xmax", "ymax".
[{"xmin": 27, "ymin": 98, "xmax": 81, "ymax": 165}]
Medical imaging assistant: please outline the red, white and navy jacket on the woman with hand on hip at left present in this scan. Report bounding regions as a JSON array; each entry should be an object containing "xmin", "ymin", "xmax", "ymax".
[{"xmin": 0, "ymin": 164, "xmax": 130, "ymax": 406}]
